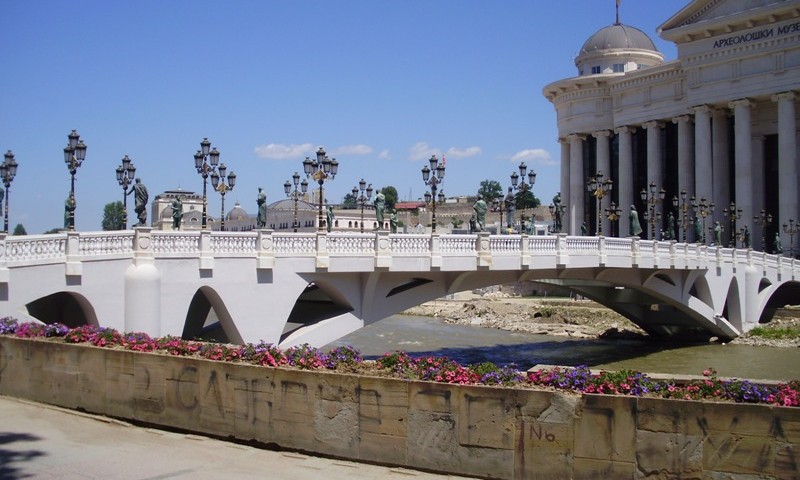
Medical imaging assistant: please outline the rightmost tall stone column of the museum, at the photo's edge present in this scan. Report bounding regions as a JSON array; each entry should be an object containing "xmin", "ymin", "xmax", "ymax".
[{"xmin": 772, "ymin": 92, "xmax": 800, "ymax": 234}]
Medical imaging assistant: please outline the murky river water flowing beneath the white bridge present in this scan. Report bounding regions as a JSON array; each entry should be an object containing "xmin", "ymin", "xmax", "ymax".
[{"xmin": 324, "ymin": 315, "xmax": 800, "ymax": 381}]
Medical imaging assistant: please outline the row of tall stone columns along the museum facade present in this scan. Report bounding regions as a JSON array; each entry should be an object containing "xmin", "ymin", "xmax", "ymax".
[{"xmin": 559, "ymin": 91, "xmax": 800, "ymax": 250}]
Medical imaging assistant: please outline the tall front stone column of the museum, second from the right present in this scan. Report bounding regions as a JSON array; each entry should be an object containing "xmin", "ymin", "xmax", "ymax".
[{"xmin": 728, "ymin": 98, "xmax": 752, "ymax": 240}]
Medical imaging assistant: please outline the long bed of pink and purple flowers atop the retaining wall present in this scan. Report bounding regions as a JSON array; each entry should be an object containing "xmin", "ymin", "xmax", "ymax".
[{"xmin": 0, "ymin": 317, "xmax": 800, "ymax": 407}]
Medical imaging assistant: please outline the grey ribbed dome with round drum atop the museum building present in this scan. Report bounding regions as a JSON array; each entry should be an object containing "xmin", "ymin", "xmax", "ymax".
[{"xmin": 575, "ymin": 23, "xmax": 664, "ymax": 76}]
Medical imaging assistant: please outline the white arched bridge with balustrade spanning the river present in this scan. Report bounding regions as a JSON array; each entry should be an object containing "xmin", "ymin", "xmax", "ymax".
[{"xmin": 0, "ymin": 227, "xmax": 800, "ymax": 347}]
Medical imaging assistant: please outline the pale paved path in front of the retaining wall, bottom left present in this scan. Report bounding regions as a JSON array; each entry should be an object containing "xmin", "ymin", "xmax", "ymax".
[{"xmin": 0, "ymin": 396, "xmax": 465, "ymax": 480}]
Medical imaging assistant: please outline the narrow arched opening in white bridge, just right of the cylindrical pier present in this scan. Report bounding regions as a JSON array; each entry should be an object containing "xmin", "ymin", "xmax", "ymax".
[{"xmin": 181, "ymin": 285, "xmax": 244, "ymax": 343}]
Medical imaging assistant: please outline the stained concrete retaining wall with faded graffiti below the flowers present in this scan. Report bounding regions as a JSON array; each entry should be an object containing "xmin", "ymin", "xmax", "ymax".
[{"xmin": 0, "ymin": 336, "xmax": 800, "ymax": 479}]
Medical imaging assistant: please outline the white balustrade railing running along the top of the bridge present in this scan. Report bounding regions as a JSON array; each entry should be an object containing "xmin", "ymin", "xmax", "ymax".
[{"xmin": 0, "ymin": 227, "xmax": 800, "ymax": 282}]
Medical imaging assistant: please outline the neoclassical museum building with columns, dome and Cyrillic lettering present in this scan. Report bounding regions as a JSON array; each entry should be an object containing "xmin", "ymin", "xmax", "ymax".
[{"xmin": 543, "ymin": 0, "xmax": 800, "ymax": 253}]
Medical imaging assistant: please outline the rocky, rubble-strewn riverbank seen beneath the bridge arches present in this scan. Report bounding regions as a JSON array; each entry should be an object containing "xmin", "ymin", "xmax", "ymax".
[{"xmin": 403, "ymin": 292, "xmax": 800, "ymax": 347}]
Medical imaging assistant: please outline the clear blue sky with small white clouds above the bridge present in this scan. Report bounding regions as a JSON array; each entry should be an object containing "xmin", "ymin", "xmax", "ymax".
[{"xmin": 0, "ymin": 0, "xmax": 688, "ymax": 234}]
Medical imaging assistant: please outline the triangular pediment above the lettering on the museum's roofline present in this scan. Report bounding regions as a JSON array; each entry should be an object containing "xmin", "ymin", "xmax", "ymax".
[{"xmin": 658, "ymin": 0, "xmax": 800, "ymax": 43}]
